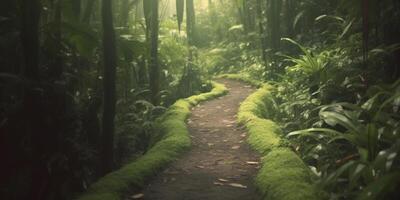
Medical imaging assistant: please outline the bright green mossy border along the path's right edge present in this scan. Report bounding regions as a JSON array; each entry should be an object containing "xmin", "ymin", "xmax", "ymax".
[{"xmin": 238, "ymin": 84, "xmax": 319, "ymax": 200}]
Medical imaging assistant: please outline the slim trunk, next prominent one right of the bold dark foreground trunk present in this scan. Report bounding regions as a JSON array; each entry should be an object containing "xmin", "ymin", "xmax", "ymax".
[{"xmin": 149, "ymin": 0, "xmax": 160, "ymax": 105}]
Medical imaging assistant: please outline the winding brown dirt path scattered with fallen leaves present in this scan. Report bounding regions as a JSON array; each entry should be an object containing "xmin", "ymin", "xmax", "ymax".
[{"xmin": 143, "ymin": 80, "xmax": 260, "ymax": 200}]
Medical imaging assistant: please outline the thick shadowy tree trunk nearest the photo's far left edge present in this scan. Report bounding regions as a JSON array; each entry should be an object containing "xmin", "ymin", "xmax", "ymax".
[{"xmin": 21, "ymin": 0, "xmax": 49, "ymax": 200}]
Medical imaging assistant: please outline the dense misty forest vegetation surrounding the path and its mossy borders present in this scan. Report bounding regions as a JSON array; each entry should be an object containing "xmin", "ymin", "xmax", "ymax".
[{"xmin": 0, "ymin": 0, "xmax": 400, "ymax": 200}]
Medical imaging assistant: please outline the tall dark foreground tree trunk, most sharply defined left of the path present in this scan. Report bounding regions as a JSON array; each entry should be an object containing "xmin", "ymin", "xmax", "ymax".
[{"xmin": 102, "ymin": 0, "xmax": 117, "ymax": 174}]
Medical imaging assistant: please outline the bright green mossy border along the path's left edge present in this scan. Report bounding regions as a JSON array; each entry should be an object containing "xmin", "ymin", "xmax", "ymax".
[{"xmin": 78, "ymin": 82, "xmax": 228, "ymax": 200}]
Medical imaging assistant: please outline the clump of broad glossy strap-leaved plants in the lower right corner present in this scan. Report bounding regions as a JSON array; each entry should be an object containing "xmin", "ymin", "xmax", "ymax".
[{"xmin": 288, "ymin": 81, "xmax": 400, "ymax": 199}]
